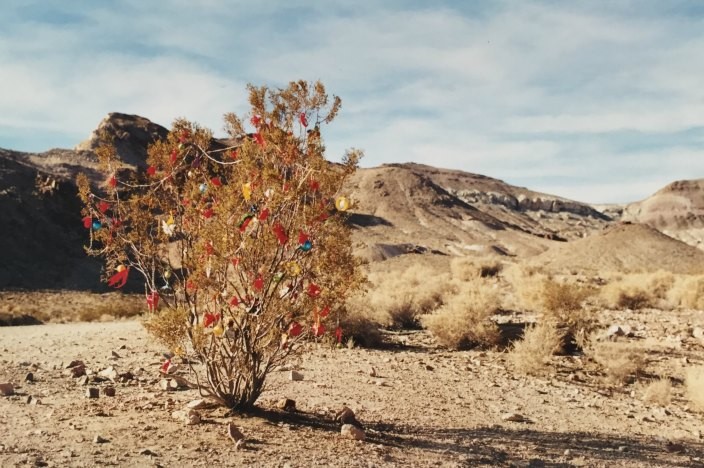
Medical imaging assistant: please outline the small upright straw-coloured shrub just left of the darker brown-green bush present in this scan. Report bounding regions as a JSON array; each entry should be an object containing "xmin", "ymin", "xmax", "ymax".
[{"xmin": 509, "ymin": 322, "xmax": 563, "ymax": 375}]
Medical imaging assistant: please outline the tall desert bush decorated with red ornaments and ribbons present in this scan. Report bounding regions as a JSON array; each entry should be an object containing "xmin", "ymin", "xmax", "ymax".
[{"xmin": 78, "ymin": 81, "xmax": 361, "ymax": 410}]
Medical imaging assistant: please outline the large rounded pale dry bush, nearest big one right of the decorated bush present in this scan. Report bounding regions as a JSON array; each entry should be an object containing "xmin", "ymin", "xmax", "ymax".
[{"xmin": 422, "ymin": 280, "xmax": 501, "ymax": 349}]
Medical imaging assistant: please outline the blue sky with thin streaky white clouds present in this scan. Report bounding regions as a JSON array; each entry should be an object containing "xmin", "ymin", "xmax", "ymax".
[{"xmin": 0, "ymin": 0, "xmax": 704, "ymax": 203}]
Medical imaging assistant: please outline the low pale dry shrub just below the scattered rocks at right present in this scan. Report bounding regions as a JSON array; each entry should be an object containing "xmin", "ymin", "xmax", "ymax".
[{"xmin": 587, "ymin": 342, "xmax": 646, "ymax": 384}]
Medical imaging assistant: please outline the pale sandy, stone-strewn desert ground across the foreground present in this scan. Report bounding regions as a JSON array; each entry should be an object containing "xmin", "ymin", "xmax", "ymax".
[{"xmin": 0, "ymin": 312, "xmax": 704, "ymax": 467}]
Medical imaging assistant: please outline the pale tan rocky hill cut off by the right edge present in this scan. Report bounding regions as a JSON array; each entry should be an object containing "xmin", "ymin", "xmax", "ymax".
[{"xmin": 622, "ymin": 179, "xmax": 704, "ymax": 250}]
